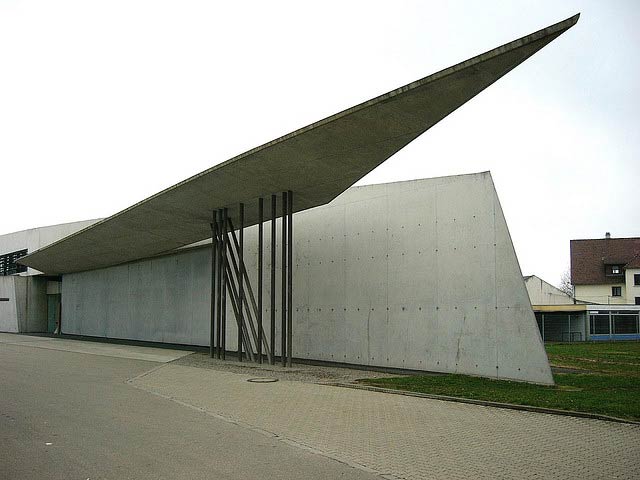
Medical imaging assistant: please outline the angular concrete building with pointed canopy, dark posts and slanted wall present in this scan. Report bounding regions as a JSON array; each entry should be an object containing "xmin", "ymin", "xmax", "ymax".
[{"xmin": 11, "ymin": 15, "xmax": 578, "ymax": 384}]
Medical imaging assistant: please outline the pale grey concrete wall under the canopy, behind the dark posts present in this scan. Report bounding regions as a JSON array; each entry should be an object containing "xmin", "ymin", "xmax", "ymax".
[{"xmin": 62, "ymin": 173, "xmax": 553, "ymax": 384}]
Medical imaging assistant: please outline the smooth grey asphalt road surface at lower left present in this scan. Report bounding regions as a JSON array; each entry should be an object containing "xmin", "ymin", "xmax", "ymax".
[{"xmin": 0, "ymin": 343, "xmax": 379, "ymax": 480}]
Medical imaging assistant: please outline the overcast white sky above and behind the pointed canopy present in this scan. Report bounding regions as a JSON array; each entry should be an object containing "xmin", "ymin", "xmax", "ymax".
[{"xmin": 0, "ymin": 0, "xmax": 640, "ymax": 284}]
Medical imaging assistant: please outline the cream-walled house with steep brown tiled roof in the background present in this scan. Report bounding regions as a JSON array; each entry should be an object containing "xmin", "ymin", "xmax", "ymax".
[{"xmin": 571, "ymin": 233, "xmax": 640, "ymax": 305}]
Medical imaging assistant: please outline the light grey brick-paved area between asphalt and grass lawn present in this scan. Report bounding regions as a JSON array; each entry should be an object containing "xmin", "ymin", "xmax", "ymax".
[{"xmin": 130, "ymin": 364, "xmax": 640, "ymax": 480}]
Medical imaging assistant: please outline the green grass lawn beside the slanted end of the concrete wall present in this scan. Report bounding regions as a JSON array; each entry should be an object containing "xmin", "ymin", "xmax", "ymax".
[{"xmin": 362, "ymin": 342, "xmax": 640, "ymax": 420}]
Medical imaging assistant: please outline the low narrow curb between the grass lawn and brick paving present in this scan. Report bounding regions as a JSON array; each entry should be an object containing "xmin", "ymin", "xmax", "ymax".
[{"xmin": 322, "ymin": 382, "xmax": 640, "ymax": 425}]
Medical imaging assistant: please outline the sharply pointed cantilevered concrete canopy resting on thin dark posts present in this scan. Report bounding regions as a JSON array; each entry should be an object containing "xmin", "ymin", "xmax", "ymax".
[{"xmin": 20, "ymin": 15, "xmax": 579, "ymax": 274}]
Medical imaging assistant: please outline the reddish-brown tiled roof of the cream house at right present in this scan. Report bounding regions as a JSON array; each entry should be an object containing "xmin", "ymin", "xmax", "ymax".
[{"xmin": 570, "ymin": 237, "xmax": 640, "ymax": 285}]
